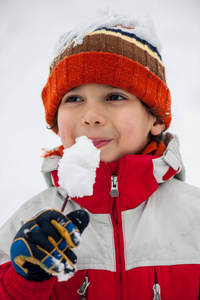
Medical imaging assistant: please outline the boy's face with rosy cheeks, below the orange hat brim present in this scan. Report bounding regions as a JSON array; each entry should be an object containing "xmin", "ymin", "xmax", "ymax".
[{"xmin": 58, "ymin": 84, "xmax": 165, "ymax": 162}]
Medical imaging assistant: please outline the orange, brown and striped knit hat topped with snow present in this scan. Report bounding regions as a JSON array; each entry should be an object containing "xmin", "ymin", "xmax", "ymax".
[{"xmin": 42, "ymin": 15, "xmax": 171, "ymax": 132}]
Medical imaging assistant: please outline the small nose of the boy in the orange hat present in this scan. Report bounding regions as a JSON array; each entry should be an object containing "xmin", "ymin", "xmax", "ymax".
[{"xmin": 81, "ymin": 104, "xmax": 106, "ymax": 126}]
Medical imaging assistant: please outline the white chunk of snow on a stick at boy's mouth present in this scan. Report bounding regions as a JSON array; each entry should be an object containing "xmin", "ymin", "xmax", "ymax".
[{"xmin": 58, "ymin": 136, "xmax": 100, "ymax": 197}]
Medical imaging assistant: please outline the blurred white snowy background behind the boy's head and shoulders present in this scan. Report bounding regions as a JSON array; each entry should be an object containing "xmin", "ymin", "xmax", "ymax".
[{"xmin": 0, "ymin": 0, "xmax": 200, "ymax": 225}]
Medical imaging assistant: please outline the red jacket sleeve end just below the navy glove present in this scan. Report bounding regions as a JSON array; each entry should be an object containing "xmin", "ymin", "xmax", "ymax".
[{"xmin": 0, "ymin": 262, "xmax": 57, "ymax": 300}]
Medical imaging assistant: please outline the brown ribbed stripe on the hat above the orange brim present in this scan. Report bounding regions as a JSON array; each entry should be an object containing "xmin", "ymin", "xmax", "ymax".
[{"xmin": 50, "ymin": 32, "xmax": 166, "ymax": 82}]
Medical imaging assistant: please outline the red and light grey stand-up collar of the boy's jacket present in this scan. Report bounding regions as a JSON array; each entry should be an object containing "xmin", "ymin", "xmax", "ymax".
[{"xmin": 42, "ymin": 134, "xmax": 185, "ymax": 213}]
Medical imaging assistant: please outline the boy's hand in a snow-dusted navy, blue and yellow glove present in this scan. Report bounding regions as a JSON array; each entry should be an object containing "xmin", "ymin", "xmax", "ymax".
[{"xmin": 11, "ymin": 209, "xmax": 89, "ymax": 281}]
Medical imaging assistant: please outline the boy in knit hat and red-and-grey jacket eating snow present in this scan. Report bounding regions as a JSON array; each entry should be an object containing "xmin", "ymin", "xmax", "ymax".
[{"xmin": 0, "ymin": 12, "xmax": 200, "ymax": 300}]
